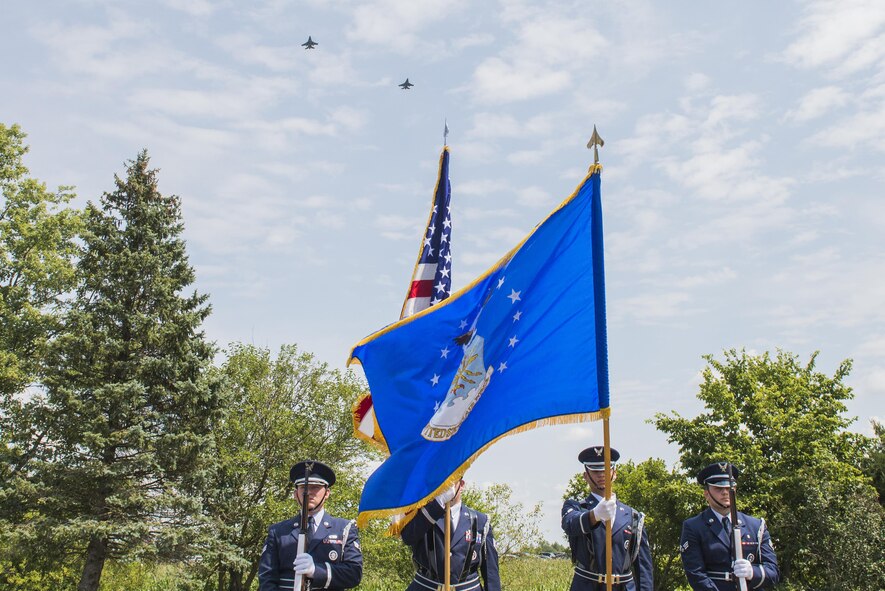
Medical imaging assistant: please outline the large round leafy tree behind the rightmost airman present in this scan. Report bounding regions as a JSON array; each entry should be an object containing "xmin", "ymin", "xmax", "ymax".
[{"xmin": 654, "ymin": 350, "xmax": 885, "ymax": 591}]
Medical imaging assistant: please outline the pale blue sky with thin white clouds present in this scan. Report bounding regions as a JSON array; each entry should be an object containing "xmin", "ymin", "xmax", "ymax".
[{"xmin": 0, "ymin": 0, "xmax": 885, "ymax": 540}]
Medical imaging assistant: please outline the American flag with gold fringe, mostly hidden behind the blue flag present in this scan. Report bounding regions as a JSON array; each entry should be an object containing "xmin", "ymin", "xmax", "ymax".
[{"xmin": 353, "ymin": 146, "xmax": 452, "ymax": 452}]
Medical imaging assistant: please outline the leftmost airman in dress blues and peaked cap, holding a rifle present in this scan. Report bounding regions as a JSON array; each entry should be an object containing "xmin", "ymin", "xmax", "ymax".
[{"xmin": 258, "ymin": 461, "xmax": 363, "ymax": 591}]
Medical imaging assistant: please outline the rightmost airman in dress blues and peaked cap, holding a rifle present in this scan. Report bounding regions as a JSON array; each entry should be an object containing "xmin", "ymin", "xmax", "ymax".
[{"xmin": 679, "ymin": 462, "xmax": 780, "ymax": 591}]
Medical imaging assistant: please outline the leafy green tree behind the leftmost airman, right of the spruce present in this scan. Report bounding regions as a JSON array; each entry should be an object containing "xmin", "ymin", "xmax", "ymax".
[{"xmin": 201, "ymin": 344, "xmax": 375, "ymax": 591}]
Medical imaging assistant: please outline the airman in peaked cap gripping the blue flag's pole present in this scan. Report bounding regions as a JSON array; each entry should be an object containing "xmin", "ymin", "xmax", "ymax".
[{"xmin": 562, "ymin": 446, "xmax": 654, "ymax": 591}]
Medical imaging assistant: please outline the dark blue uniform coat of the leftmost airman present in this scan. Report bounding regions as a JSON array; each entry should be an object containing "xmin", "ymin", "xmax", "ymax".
[{"xmin": 258, "ymin": 513, "xmax": 363, "ymax": 591}]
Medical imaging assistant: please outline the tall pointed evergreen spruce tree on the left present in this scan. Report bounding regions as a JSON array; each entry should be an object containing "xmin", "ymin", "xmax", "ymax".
[{"xmin": 37, "ymin": 152, "xmax": 220, "ymax": 591}]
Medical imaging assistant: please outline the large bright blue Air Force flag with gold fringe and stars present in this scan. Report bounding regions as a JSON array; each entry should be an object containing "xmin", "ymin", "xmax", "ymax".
[{"xmin": 351, "ymin": 172, "xmax": 609, "ymax": 522}]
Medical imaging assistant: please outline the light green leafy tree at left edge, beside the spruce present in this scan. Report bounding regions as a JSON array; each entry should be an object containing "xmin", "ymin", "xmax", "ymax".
[{"xmin": 0, "ymin": 124, "xmax": 81, "ymax": 589}]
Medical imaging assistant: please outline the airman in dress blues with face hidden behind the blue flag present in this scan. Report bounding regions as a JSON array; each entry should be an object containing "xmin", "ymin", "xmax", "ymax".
[{"xmin": 401, "ymin": 480, "xmax": 501, "ymax": 591}]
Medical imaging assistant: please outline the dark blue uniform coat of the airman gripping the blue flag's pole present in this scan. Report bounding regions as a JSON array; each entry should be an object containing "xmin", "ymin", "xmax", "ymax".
[{"xmin": 562, "ymin": 495, "xmax": 654, "ymax": 591}]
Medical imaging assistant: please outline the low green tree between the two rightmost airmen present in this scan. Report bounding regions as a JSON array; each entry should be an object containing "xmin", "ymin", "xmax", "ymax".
[{"xmin": 563, "ymin": 459, "xmax": 704, "ymax": 591}]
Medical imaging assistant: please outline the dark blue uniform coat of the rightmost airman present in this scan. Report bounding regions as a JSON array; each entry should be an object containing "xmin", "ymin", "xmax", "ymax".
[{"xmin": 679, "ymin": 508, "xmax": 780, "ymax": 591}]
